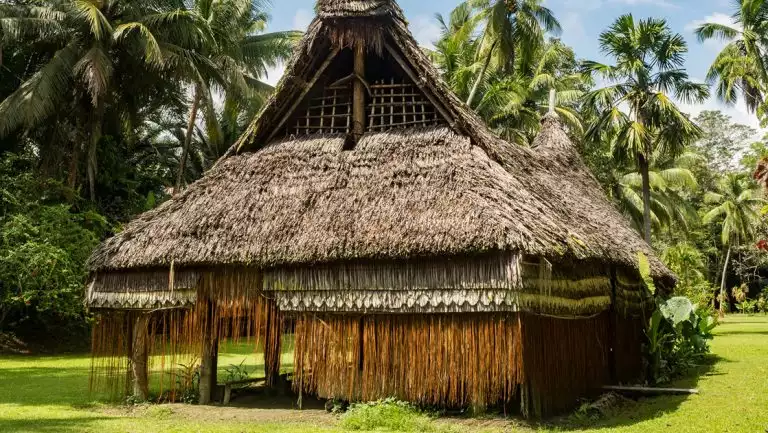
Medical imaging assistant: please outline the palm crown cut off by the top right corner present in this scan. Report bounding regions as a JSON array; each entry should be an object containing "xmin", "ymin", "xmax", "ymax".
[{"xmin": 696, "ymin": 0, "xmax": 768, "ymax": 111}]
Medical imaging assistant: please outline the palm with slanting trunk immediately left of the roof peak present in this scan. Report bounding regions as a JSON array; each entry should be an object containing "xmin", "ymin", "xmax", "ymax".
[{"xmin": 176, "ymin": 0, "xmax": 301, "ymax": 191}]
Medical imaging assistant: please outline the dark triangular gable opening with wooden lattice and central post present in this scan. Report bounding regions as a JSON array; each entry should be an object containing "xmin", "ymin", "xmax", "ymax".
[{"xmin": 272, "ymin": 46, "xmax": 448, "ymax": 141}]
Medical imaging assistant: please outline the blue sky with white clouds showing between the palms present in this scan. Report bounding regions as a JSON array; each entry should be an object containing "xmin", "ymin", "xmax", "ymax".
[{"xmin": 260, "ymin": 0, "xmax": 758, "ymax": 127}]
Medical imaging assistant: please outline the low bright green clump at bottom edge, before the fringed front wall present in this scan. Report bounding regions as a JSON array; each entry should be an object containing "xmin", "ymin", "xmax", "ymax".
[{"xmin": 341, "ymin": 398, "xmax": 436, "ymax": 432}]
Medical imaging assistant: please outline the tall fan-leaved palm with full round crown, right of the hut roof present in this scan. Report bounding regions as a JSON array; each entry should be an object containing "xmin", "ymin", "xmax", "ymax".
[{"xmin": 584, "ymin": 14, "xmax": 709, "ymax": 244}]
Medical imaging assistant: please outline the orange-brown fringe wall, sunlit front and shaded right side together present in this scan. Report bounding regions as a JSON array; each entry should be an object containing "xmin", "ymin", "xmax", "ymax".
[{"xmin": 294, "ymin": 312, "xmax": 620, "ymax": 416}]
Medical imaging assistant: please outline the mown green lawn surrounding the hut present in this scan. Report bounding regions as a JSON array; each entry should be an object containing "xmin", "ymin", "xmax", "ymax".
[{"xmin": 0, "ymin": 315, "xmax": 768, "ymax": 433}]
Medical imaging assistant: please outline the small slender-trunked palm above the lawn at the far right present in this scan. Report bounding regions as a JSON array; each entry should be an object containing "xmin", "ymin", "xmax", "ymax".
[{"xmin": 703, "ymin": 174, "xmax": 765, "ymax": 315}]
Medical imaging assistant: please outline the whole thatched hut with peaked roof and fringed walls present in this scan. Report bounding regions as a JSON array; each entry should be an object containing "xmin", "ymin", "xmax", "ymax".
[{"xmin": 82, "ymin": 0, "xmax": 674, "ymax": 416}]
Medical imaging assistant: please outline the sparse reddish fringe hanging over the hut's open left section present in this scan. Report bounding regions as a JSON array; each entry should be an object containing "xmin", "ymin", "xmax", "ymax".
[{"xmin": 90, "ymin": 270, "xmax": 272, "ymax": 401}]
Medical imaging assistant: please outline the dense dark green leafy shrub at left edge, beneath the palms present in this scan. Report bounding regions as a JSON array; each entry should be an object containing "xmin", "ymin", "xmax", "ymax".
[{"xmin": 0, "ymin": 155, "xmax": 107, "ymax": 341}]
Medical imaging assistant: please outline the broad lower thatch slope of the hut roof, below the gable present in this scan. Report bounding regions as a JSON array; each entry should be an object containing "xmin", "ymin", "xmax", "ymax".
[{"xmin": 89, "ymin": 125, "xmax": 671, "ymax": 284}]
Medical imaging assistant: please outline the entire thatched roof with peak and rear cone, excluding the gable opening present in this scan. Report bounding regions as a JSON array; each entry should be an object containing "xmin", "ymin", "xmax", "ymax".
[{"xmin": 89, "ymin": 0, "xmax": 673, "ymax": 306}]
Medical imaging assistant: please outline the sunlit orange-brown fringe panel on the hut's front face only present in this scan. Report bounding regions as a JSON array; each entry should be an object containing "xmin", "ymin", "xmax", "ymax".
[{"xmin": 294, "ymin": 314, "xmax": 524, "ymax": 407}]
